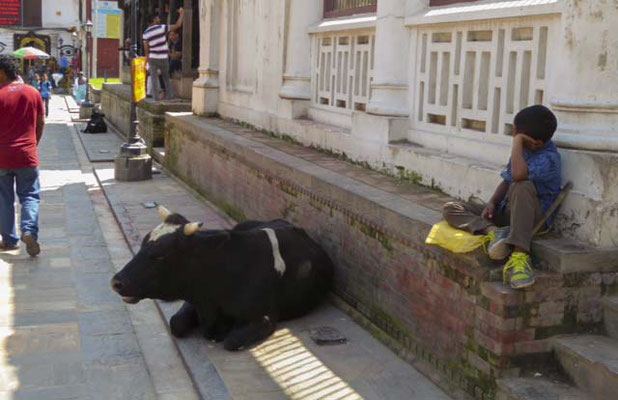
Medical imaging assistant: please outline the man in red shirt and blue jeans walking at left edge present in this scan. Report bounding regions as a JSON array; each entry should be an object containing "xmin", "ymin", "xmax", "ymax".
[{"xmin": 0, "ymin": 54, "xmax": 45, "ymax": 256}]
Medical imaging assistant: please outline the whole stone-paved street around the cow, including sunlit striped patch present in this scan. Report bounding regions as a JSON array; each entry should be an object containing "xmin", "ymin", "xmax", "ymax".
[{"xmin": 0, "ymin": 97, "xmax": 448, "ymax": 400}]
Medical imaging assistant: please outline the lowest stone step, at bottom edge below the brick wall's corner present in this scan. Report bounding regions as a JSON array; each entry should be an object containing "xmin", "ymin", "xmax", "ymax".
[{"xmin": 496, "ymin": 377, "xmax": 592, "ymax": 400}]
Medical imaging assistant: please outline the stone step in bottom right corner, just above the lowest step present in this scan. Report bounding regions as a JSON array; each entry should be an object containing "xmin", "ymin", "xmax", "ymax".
[{"xmin": 552, "ymin": 335, "xmax": 618, "ymax": 399}]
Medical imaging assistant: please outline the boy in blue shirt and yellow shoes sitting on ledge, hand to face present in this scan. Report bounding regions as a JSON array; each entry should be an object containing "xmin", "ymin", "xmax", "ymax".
[{"xmin": 443, "ymin": 105, "xmax": 561, "ymax": 289}]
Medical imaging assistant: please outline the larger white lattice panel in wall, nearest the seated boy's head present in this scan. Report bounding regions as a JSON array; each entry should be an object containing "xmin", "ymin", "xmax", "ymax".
[{"xmin": 412, "ymin": 19, "xmax": 556, "ymax": 137}]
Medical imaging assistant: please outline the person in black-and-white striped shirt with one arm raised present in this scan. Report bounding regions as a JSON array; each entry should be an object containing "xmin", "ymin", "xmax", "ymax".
[{"xmin": 142, "ymin": 8, "xmax": 184, "ymax": 101}]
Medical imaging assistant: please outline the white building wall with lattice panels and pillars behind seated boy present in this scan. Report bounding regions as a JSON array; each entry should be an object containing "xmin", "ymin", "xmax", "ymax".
[{"xmin": 193, "ymin": 0, "xmax": 618, "ymax": 247}]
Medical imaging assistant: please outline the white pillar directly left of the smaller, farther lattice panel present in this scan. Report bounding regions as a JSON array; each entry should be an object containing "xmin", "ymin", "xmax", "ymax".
[{"xmin": 279, "ymin": 0, "xmax": 324, "ymax": 100}]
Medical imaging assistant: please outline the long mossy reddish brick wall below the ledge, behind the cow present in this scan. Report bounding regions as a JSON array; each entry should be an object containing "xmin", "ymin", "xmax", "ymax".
[{"xmin": 165, "ymin": 115, "xmax": 615, "ymax": 399}]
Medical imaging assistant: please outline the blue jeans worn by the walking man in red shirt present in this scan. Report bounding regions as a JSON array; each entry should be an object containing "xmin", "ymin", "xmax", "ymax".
[{"xmin": 0, "ymin": 167, "xmax": 41, "ymax": 245}]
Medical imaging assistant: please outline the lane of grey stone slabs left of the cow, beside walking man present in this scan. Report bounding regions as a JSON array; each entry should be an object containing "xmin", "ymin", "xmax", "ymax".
[{"xmin": 0, "ymin": 96, "xmax": 199, "ymax": 400}]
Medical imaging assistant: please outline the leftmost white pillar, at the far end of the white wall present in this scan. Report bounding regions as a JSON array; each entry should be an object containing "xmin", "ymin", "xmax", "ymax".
[{"xmin": 193, "ymin": 0, "xmax": 221, "ymax": 116}]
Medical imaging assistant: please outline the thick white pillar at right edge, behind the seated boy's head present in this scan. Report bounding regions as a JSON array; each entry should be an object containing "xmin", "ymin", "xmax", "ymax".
[{"xmin": 547, "ymin": 0, "xmax": 618, "ymax": 152}]
